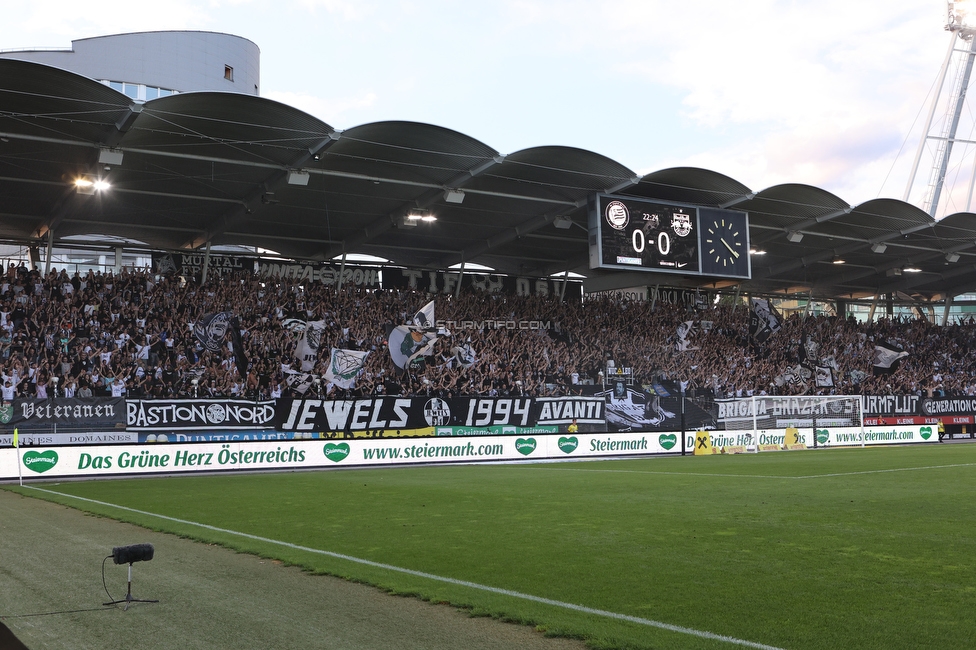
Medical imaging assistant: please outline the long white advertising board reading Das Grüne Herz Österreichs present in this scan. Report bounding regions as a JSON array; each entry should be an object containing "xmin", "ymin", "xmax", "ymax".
[{"xmin": 0, "ymin": 433, "xmax": 681, "ymax": 480}]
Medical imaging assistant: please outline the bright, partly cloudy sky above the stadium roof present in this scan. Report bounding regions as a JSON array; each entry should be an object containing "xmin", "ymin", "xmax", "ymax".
[{"xmin": 0, "ymin": 0, "xmax": 964, "ymax": 209}]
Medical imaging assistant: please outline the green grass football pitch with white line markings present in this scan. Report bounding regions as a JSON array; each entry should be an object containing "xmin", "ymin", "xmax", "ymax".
[{"xmin": 7, "ymin": 444, "xmax": 976, "ymax": 650}]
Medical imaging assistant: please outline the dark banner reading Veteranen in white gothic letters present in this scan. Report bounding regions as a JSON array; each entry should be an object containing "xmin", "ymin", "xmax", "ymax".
[{"xmin": 0, "ymin": 397, "xmax": 125, "ymax": 431}]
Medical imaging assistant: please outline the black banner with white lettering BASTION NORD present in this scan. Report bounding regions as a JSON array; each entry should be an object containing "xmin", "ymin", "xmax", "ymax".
[{"xmin": 125, "ymin": 399, "xmax": 275, "ymax": 431}]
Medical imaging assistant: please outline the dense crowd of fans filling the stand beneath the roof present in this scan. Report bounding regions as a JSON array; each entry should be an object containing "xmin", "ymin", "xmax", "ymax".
[{"xmin": 0, "ymin": 264, "xmax": 976, "ymax": 402}]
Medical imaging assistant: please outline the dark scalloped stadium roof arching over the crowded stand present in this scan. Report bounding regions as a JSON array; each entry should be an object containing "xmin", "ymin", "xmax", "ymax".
[{"xmin": 0, "ymin": 59, "xmax": 976, "ymax": 302}]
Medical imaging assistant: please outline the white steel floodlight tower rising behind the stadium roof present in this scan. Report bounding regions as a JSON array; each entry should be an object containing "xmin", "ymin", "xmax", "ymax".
[{"xmin": 904, "ymin": 0, "xmax": 976, "ymax": 218}]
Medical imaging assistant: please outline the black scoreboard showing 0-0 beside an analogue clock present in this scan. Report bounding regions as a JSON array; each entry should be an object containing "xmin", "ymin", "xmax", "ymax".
[{"xmin": 589, "ymin": 194, "xmax": 752, "ymax": 279}]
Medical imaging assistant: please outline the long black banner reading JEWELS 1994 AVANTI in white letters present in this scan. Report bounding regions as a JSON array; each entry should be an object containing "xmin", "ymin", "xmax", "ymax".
[{"xmin": 275, "ymin": 397, "xmax": 607, "ymax": 437}]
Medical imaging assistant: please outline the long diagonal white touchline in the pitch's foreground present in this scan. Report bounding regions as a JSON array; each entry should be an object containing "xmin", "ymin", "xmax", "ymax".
[{"xmin": 24, "ymin": 485, "xmax": 784, "ymax": 650}]
